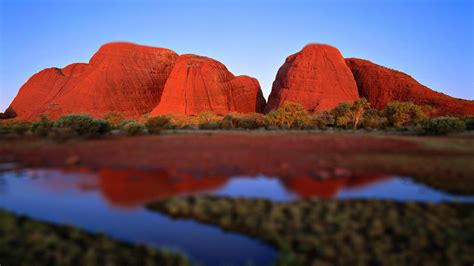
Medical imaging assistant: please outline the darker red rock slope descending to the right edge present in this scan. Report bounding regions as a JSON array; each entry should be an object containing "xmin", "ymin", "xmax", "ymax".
[{"xmin": 346, "ymin": 58, "xmax": 474, "ymax": 116}]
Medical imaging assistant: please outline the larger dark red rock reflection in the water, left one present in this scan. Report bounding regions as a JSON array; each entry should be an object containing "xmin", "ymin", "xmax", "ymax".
[{"xmin": 98, "ymin": 168, "xmax": 228, "ymax": 207}]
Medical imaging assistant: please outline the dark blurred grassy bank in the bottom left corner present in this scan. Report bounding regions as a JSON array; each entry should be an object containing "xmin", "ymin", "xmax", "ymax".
[{"xmin": 0, "ymin": 210, "xmax": 188, "ymax": 266}]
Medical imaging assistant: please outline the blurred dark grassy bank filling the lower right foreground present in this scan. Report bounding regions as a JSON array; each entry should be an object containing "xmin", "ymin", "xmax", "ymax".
[{"xmin": 147, "ymin": 196, "xmax": 474, "ymax": 265}]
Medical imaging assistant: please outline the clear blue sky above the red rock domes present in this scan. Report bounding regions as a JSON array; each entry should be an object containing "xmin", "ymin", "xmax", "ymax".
[{"xmin": 0, "ymin": 0, "xmax": 474, "ymax": 110}]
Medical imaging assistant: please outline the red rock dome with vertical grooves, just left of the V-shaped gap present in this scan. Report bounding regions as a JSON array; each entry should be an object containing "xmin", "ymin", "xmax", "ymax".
[{"xmin": 150, "ymin": 54, "xmax": 265, "ymax": 116}]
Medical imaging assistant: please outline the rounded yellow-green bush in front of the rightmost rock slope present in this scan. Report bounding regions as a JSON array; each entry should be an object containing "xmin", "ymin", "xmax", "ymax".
[{"xmin": 382, "ymin": 102, "xmax": 427, "ymax": 128}]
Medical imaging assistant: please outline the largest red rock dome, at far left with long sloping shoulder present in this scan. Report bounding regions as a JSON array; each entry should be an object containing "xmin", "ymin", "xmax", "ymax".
[{"xmin": 6, "ymin": 43, "xmax": 178, "ymax": 119}]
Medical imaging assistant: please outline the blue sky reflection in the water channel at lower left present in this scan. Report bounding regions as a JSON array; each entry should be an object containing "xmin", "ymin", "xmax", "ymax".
[{"xmin": 0, "ymin": 170, "xmax": 275, "ymax": 265}]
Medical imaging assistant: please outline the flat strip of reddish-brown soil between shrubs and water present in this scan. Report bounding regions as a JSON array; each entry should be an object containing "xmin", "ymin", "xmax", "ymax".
[{"xmin": 0, "ymin": 131, "xmax": 474, "ymax": 195}]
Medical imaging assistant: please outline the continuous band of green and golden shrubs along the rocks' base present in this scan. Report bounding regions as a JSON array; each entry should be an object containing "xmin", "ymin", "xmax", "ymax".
[{"xmin": 0, "ymin": 98, "xmax": 474, "ymax": 139}]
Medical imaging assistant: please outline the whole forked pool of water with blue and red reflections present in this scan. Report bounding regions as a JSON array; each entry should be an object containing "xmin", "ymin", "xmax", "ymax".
[{"xmin": 0, "ymin": 167, "xmax": 474, "ymax": 265}]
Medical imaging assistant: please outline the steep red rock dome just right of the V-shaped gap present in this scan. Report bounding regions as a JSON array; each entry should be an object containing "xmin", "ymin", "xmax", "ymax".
[{"xmin": 265, "ymin": 44, "xmax": 359, "ymax": 112}]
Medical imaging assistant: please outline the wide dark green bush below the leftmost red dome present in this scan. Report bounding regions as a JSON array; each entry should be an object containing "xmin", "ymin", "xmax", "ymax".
[{"xmin": 54, "ymin": 114, "xmax": 112, "ymax": 137}]
